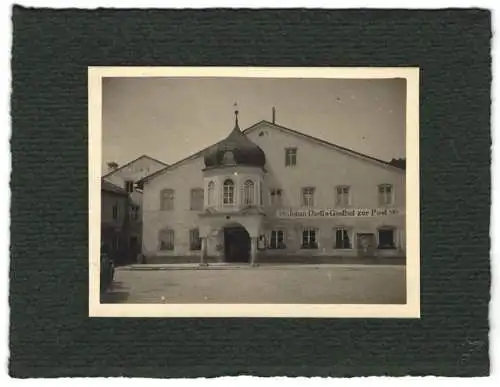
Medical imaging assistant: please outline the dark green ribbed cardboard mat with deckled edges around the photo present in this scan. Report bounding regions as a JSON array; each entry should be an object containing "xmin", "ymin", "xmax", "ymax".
[{"xmin": 9, "ymin": 7, "xmax": 491, "ymax": 378}]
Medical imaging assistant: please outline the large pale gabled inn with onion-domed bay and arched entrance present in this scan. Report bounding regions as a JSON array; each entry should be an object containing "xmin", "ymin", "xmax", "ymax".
[{"xmin": 140, "ymin": 112, "xmax": 406, "ymax": 263}]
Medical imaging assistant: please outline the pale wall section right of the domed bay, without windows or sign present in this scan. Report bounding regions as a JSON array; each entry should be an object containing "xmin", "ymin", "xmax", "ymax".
[{"xmin": 248, "ymin": 125, "xmax": 406, "ymax": 256}]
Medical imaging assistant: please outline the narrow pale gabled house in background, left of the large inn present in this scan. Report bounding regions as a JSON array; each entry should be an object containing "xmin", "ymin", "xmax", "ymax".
[{"xmin": 103, "ymin": 155, "xmax": 167, "ymax": 262}]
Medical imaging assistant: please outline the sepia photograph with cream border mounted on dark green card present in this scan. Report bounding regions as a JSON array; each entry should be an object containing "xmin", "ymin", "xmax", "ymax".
[{"xmin": 89, "ymin": 67, "xmax": 419, "ymax": 317}]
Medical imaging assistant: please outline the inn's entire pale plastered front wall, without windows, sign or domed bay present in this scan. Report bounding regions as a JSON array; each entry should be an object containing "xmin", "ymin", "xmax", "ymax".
[{"xmin": 143, "ymin": 125, "xmax": 406, "ymax": 261}]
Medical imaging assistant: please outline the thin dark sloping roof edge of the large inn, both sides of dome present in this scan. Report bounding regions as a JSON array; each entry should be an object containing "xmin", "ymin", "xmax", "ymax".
[{"xmin": 139, "ymin": 120, "xmax": 404, "ymax": 184}]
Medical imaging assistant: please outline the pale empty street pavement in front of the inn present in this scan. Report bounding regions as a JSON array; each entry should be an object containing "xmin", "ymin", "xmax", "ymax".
[{"xmin": 102, "ymin": 264, "xmax": 406, "ymax": 304}]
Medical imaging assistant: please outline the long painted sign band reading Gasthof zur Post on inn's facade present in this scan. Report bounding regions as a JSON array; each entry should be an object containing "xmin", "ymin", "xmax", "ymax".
[{"xmin": 276, "ymin": 208, "xmax": 400, "ymax": 218}]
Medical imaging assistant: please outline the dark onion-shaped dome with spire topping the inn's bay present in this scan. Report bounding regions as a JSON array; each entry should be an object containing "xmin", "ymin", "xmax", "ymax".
[{"xmin": 204, "ymin": 111, "xmax": 266, "ymax": 168}]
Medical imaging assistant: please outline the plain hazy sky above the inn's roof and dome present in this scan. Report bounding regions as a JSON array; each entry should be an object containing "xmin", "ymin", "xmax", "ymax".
[{"xmin": 102, "ymin": 77, "xmax": 406, "ymax": 168}]
